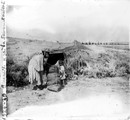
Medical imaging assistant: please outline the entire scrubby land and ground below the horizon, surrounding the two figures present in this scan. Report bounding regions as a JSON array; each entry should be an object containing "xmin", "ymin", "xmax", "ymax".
[{"xmin": 7, "ymin": 38, "xmax": 130, "ymax": 120}]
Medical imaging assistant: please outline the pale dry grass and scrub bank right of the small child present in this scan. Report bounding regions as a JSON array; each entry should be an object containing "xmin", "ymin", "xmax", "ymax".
[{"xmin": 68, "ymin": 48, "xmax": 130, "ymax": 78}]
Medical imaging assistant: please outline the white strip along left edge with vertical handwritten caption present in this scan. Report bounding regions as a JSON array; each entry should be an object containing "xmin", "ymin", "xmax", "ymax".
[{"xmin": 0, "ymin": 0, "xmax": 7, "ymax": 120}]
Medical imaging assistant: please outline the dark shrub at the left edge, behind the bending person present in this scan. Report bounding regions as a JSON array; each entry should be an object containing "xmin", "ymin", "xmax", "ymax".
[{"xmin": 6, "ymin": 59, "xmax": 28, "ymax": 87}]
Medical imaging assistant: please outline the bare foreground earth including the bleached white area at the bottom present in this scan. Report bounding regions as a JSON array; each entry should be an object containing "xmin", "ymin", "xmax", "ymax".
[{"xmin": 8, "ymin": 76, "xmax": 130, "ymax": 120}]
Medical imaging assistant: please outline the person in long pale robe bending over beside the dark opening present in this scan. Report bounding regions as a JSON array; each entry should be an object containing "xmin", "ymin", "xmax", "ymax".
[{"xmin": 28, "ymin": 51, "xmax": 49, "ymax": 90}]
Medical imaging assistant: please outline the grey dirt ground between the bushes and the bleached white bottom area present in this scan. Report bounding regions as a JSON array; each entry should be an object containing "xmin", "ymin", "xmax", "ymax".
[{"xmin": 7, "ymin": 76, "xmax": 130, "ymax": 118}]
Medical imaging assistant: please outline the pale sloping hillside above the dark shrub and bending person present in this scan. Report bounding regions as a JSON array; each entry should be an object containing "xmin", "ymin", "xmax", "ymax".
[{"xmin": 7, "ymin": 38, "xmax": 74, "ymax": 64}]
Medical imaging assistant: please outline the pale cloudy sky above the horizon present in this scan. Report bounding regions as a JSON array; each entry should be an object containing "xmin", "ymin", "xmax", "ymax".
[{"xmin": 6, "ymin": 0, "xmax": 130, "ymax": 42}]
